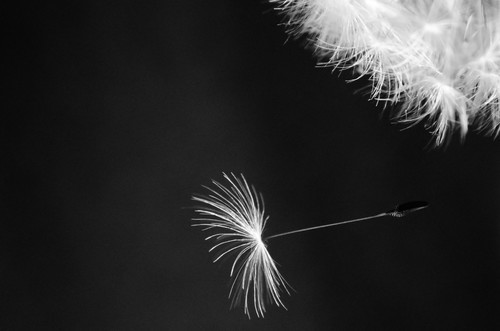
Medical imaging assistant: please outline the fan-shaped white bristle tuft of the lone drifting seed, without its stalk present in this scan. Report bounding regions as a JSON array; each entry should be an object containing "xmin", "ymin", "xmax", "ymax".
[{"xmin": 193, "ymin": 174, "xmax": 289, "ymax": 318}]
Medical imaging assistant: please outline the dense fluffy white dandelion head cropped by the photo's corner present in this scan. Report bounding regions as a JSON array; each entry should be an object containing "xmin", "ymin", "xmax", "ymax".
[{"xmin": 276, "ymin": 0, "xmax": 500, "ymax": 145}]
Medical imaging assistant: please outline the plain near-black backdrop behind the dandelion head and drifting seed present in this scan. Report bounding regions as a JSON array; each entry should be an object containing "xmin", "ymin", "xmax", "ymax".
[{"xmin": 4, "ymin": 0, "xmax": 500, "ymax": 330}]
